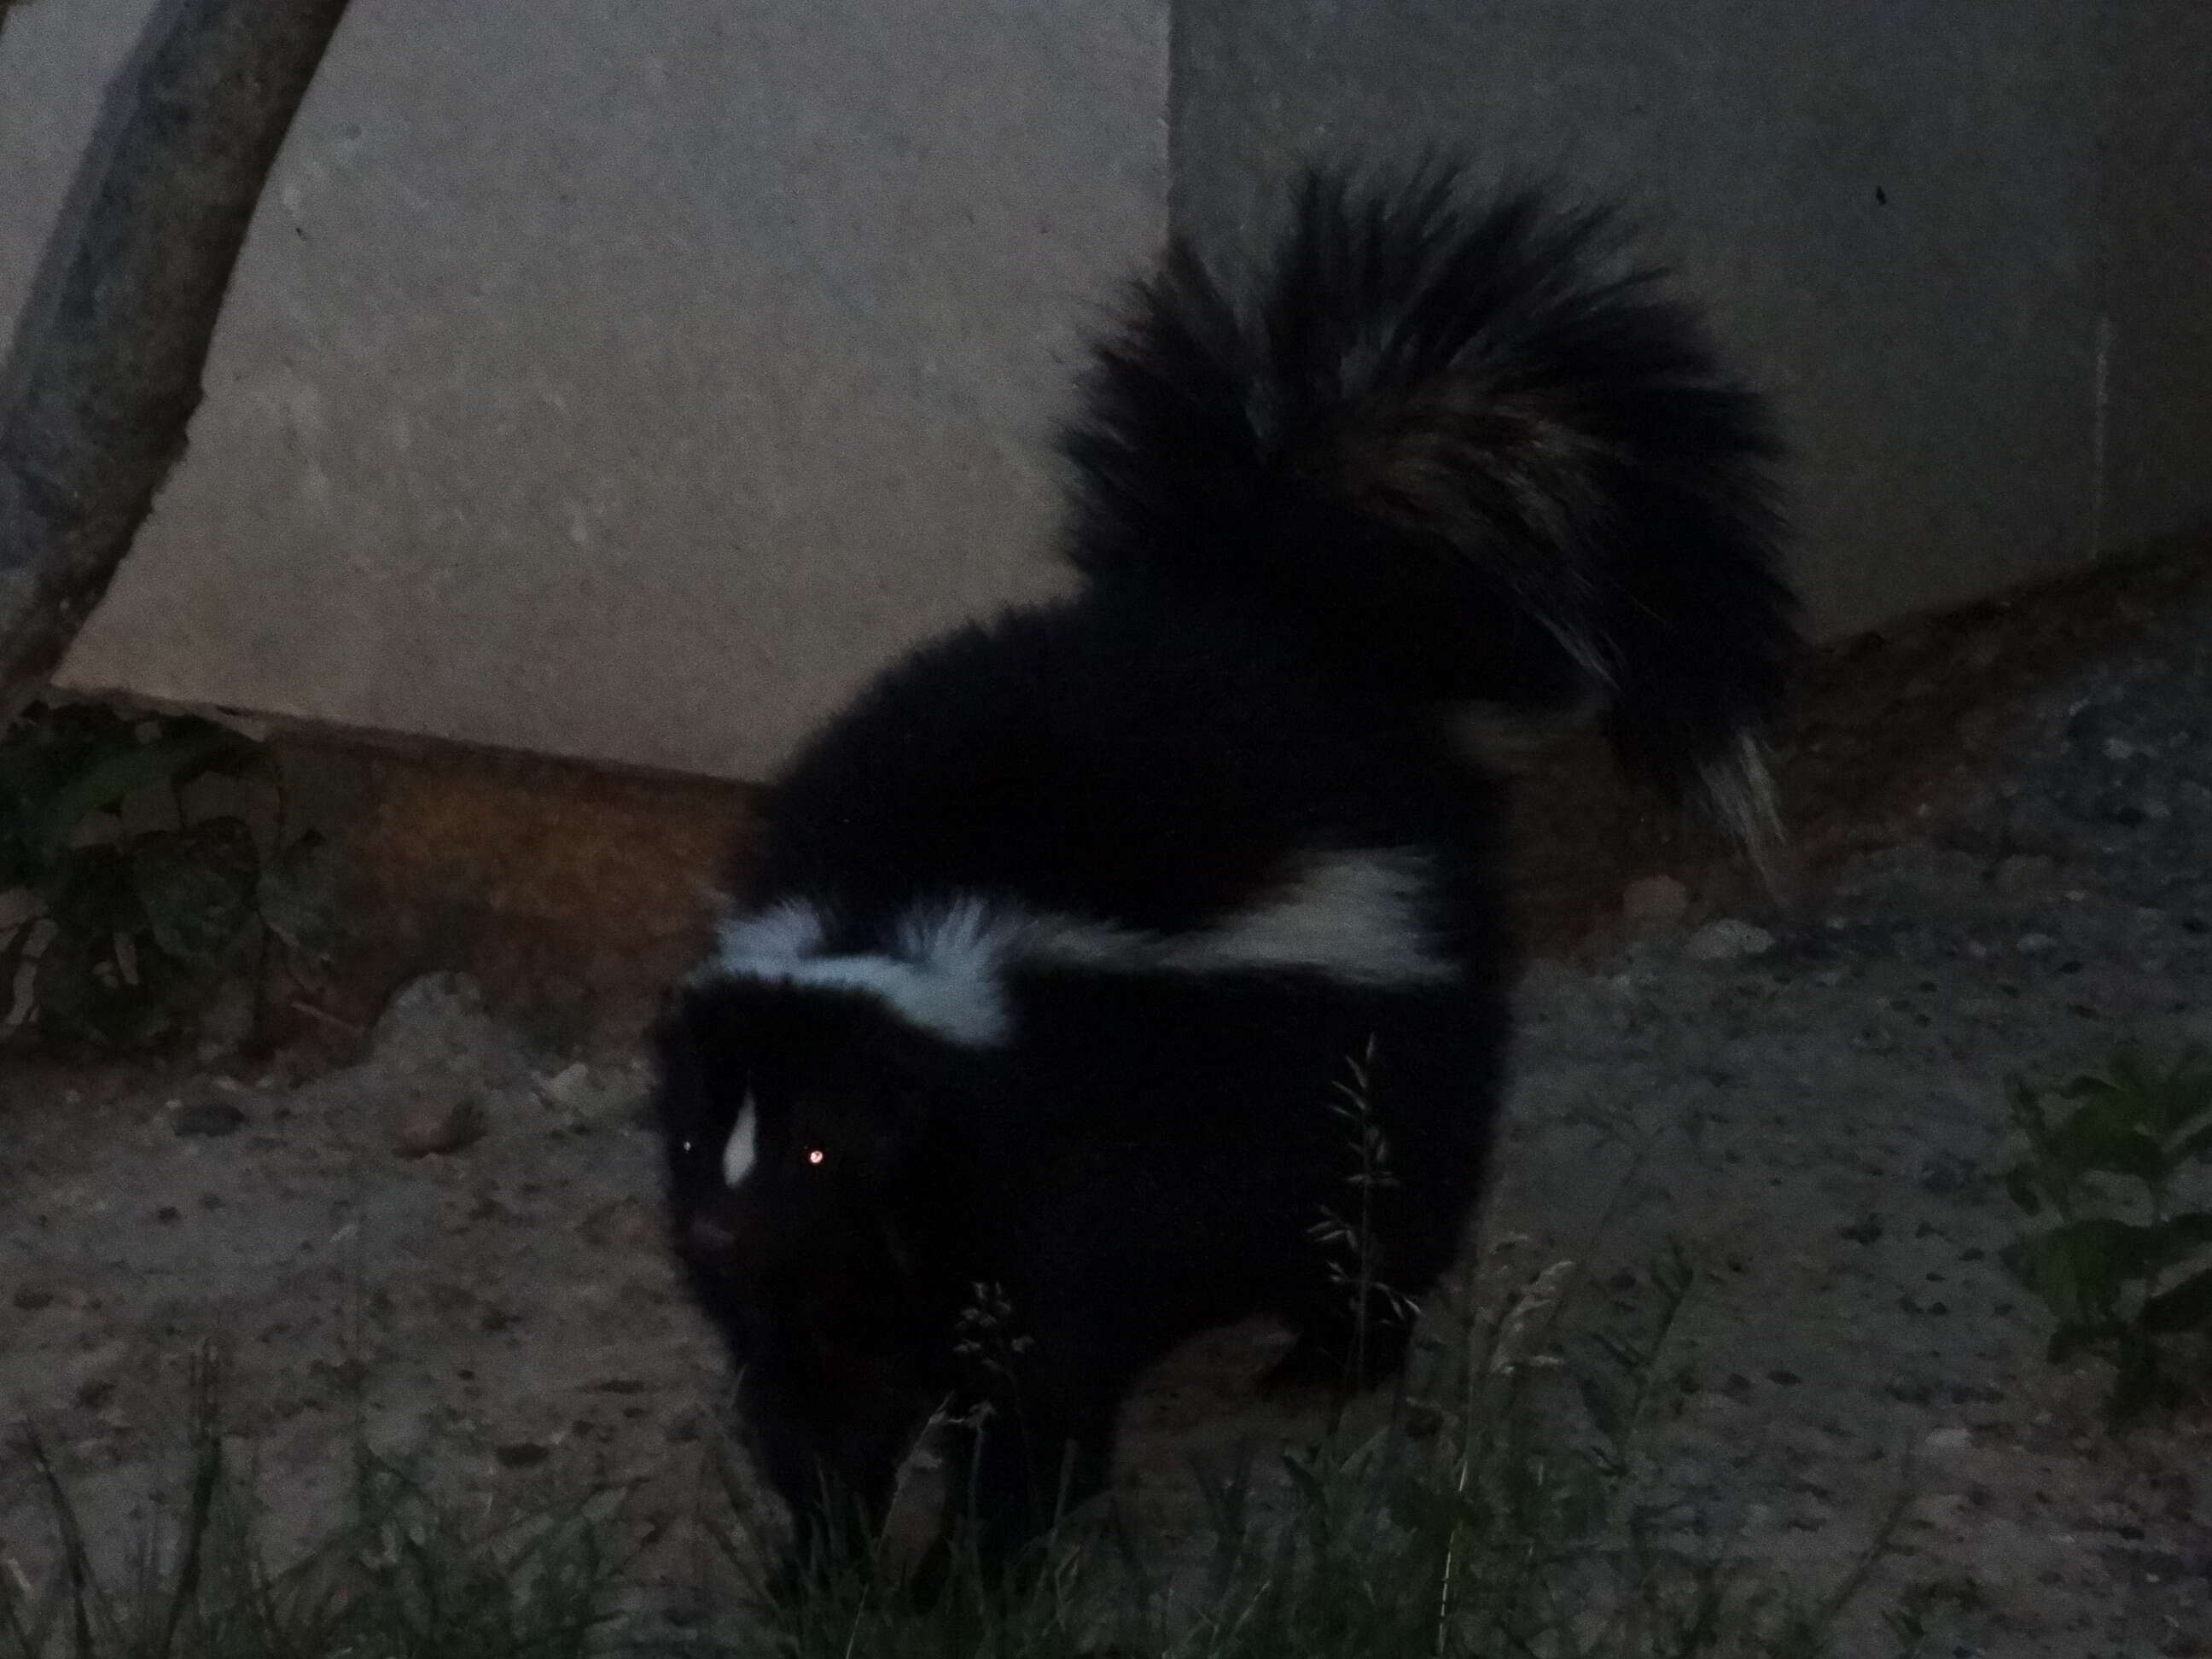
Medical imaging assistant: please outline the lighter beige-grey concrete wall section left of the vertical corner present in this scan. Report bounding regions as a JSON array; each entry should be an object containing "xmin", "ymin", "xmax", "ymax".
[{"xmin": 0, "ymin": 0, "xmax": 1168, "ymax": 777}]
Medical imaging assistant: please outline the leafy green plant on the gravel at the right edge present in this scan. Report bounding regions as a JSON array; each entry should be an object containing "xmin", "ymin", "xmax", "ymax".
[{"xmin": 2004, "ymin": 1053, "xmax": 2212, "ymax": 1423}]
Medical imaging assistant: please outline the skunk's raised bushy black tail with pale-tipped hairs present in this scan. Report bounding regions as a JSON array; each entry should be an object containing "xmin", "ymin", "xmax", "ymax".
[{"xmin": 1062, "ymin": 168, "xmax": 1794, "ymax": 847}]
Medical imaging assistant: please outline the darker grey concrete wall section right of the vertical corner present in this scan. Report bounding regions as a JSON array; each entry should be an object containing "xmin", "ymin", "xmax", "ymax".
[{"xmin": 1174, "ymin": 0, "xmax": 2212, "ymax": 632}]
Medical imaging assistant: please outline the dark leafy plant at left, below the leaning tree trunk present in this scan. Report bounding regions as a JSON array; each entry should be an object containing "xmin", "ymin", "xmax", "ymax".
[{"xmin": 0, "ymin": 703, "xmax": 318, "ymax": 1046}]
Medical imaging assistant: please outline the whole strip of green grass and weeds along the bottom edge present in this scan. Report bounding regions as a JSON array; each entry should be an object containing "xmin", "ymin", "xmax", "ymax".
[{"xmin": 0, "ymin": 1254, "xmax": 1884, "ymax": 1659}]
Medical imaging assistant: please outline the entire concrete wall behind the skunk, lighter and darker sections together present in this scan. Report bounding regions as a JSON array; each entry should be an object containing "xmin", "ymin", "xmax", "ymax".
[{"xmin": 0, "ymin": 0, "xmax": 2212, "ymax": 777}]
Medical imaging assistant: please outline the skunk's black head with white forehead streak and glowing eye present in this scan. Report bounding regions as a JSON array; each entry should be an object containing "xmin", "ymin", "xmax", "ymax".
[{"xmin": 659, "ymin": 978, "xmax": 960, "ymax": 1349}]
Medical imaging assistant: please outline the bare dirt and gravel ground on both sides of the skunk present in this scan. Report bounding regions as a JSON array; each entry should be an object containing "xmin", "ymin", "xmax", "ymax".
[{"xmin": 0, "ymin": 556, "xmax": 2212, "ymax": 1659}]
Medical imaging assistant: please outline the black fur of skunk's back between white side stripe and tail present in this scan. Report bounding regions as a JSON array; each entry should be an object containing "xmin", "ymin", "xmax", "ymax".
[{"xmin": 750, "ymin": 584, "xmax": 1495, "ymax": 945}]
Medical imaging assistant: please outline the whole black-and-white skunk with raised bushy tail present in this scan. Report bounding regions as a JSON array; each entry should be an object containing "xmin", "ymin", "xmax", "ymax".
[{"xmin": 657, "ymin": 168, "xmax": 1794, "ymax": 1583}]
